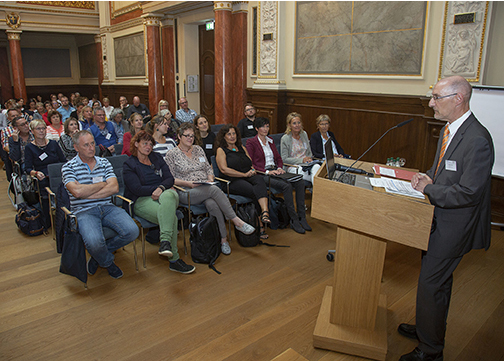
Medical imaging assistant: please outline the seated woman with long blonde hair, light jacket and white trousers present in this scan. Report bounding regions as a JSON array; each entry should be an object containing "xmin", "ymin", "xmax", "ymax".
[{"xmin": 280, "ymin": 113, "xmax": 320, "ymax": 184}]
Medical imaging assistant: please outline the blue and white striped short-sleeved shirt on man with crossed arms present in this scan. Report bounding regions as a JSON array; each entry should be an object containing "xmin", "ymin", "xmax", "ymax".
[{"xmin": 61, "ymin": 155, "xmax": 117, "ymax": 214}]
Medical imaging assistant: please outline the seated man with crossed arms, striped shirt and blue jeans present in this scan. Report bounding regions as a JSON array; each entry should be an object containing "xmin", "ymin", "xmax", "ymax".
[{"xmin": 61, "ymin": 130, "xmax": 138, "ymax": 279}]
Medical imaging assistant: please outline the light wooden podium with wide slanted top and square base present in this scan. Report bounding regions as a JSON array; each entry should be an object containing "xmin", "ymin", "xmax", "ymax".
[{"xmin": 311, "ymin": 158, "xmax": 434, "ymax": 360}]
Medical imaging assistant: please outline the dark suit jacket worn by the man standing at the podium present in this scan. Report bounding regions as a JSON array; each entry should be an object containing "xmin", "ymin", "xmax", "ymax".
[{"xmin": 424, "ymin": 114, "xmax": 494, "ymax": 258}]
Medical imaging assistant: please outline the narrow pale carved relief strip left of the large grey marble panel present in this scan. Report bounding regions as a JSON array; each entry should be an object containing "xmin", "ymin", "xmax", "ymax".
[{"xmin": 259, "ymin": 1, "xmax": 278, "ymax": 76}]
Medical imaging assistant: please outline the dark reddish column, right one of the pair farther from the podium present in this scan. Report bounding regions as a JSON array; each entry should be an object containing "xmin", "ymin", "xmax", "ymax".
[{"xmin": 161, "ymin": 19, "xmax": 177, "ymax": 114}]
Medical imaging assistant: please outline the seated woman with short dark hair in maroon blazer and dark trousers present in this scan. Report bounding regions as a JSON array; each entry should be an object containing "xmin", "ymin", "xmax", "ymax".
[{"xmin": 247, "ymin": 117, "xmax": 311, "ymax": 234}]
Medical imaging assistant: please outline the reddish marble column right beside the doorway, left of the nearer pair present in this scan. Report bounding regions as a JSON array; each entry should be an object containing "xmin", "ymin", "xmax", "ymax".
[{"xmin": 214, "ymin": 1, "xmax": 233, "ymax": 124}]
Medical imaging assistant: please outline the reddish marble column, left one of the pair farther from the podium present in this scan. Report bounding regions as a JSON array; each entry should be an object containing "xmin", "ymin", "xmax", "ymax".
[{"xmin": 142, "ymin": 14, "xmax": 163, "ymax": 114}]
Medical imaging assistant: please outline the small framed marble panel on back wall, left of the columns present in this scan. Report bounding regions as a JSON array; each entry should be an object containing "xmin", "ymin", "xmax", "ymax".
[{"xmin": 114, "ymin": 33, "xmax": 145, "ymax": 77}]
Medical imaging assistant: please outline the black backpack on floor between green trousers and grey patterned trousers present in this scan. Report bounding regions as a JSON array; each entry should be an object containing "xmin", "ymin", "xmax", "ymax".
[{"xmin": 189, "ymin": 216, "xmax": 221, "ymax": 274}]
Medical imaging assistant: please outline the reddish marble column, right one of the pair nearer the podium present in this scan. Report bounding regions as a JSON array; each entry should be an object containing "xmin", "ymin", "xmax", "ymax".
[{"xmin": 231, "ymin": 1, "xmax": 248, "ymax": 125}]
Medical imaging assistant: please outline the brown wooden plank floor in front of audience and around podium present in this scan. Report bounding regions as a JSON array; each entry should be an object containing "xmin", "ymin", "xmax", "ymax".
[{"xmin": 0, "ymin": 172, "xmax": 504, "ymax": 361}]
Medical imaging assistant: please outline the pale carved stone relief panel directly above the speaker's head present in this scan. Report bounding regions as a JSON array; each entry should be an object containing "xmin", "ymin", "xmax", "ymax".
[{"xmin": 439, "ymin": 1, "xmax": 488, "ymax": 82}]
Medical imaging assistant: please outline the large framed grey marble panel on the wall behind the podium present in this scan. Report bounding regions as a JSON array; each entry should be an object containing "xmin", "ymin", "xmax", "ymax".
[{"xmin": 295, "ymin": 1, "xmax": 427, "ymax": 75}]
